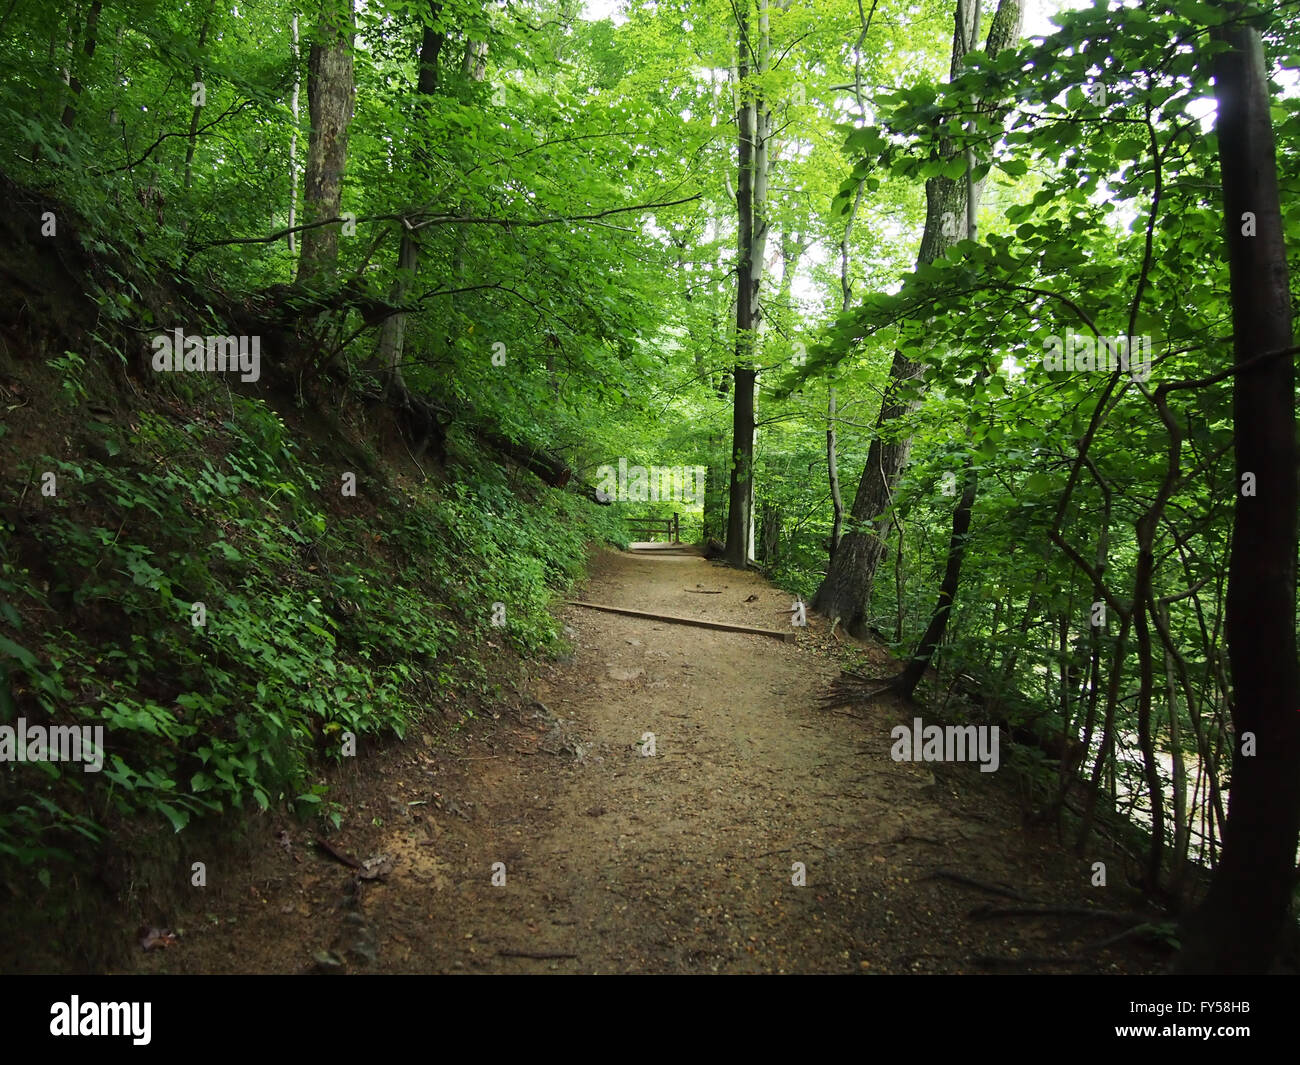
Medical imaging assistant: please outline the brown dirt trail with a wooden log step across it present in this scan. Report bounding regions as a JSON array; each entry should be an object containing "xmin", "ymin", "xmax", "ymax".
[{"xmin": 140, "ymin": 551, "xmax": 1154, "ymax": 973}]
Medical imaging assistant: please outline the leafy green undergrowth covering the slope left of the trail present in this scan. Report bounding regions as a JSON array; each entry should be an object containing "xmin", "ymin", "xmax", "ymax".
[{"xmin": 0, "ymin": 398, "xmax": 616, "ymax": 862}]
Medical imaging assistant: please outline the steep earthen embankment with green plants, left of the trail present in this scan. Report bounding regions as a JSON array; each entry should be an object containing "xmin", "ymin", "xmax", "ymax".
[{"xmin": 0, "ymin": 176, "xmax": 620, "ymax": 971}]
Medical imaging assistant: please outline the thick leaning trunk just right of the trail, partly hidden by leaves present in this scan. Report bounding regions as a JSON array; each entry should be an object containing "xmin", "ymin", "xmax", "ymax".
[{"xmin": 813, "ymin": 0, "xmax": 1021, "ymax": 636}]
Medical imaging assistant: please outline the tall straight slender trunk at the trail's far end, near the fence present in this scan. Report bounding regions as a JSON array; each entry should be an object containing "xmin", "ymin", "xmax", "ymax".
[{"xmin": 725, "ymin": 0, "xmax": 771, "ymax": 567}]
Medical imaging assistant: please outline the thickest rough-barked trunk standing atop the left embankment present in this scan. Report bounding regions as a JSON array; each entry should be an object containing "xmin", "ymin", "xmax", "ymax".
[{"xmin": 298, "ymin": 0, "xmax": 356, "ymax": 282}]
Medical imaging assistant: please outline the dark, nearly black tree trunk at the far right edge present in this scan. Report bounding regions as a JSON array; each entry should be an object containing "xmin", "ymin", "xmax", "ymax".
[{"xmin": 1175, "ymin": 4, "xmax": 1300, "ymax": 973}]
